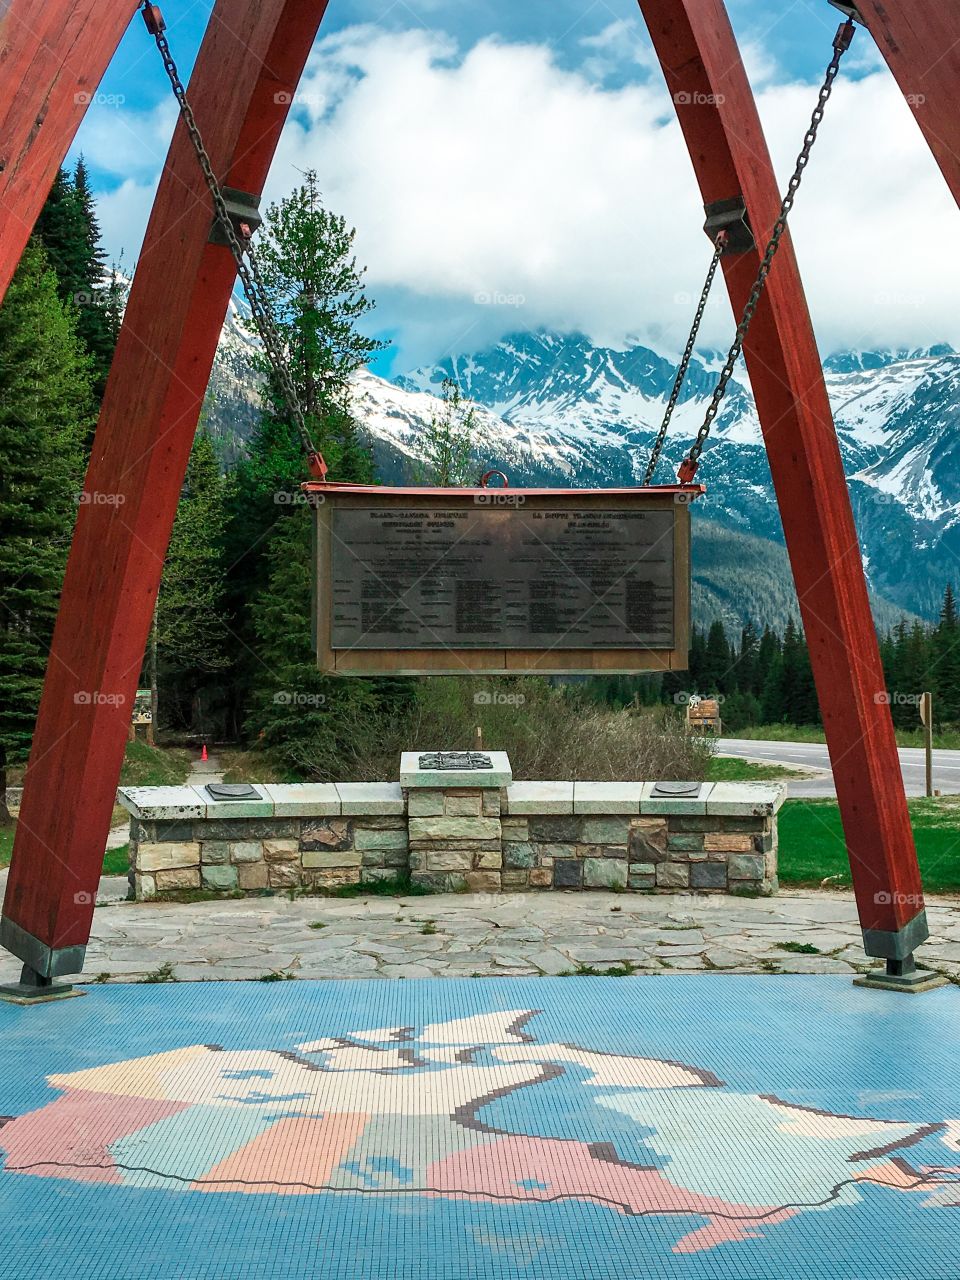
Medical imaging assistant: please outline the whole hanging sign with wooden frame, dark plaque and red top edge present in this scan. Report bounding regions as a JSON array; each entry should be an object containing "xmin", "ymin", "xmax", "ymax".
[{"xmin": 312, "ymin": 483, "xmax": 703, "ymax": 676}]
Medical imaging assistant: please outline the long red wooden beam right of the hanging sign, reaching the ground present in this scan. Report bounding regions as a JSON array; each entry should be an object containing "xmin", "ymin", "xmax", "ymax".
[{"xmin": 639, "ymin": 0, "xmax": 927, "ymax": 973}]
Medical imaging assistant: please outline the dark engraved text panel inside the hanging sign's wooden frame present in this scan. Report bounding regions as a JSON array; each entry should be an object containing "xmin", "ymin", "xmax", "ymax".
[{"xmin": 330, "ymin": 506, "xmax": 675, "ymax": 650}]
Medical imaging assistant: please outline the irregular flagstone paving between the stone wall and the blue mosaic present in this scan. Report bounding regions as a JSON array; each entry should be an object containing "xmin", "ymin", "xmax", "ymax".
[{"xmin": 0, "ymin": 873, "xmax": 960, "ymax": 982}]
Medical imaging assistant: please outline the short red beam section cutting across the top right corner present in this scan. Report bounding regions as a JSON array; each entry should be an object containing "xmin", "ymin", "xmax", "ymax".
[{"xmin": 856, "ymin": 0, "xmax": 960, "ymax": 205}]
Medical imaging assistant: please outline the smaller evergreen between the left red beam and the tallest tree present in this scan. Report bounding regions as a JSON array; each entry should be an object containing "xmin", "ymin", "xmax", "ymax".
[{"xmin": 156, "ymin": 426, "xmax": 230, "ymax": 728}]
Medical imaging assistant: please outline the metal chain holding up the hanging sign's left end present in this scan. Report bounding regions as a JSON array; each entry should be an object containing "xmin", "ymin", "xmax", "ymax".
[{"xmin": 141, "ymin": 0, "xmax": 326, "ymax": 479}]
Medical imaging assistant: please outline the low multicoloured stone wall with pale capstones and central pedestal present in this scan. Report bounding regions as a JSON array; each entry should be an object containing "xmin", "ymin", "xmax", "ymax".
[{"xmin": 119, "ymin": 753, "xmax": 786, "ymax": 900}]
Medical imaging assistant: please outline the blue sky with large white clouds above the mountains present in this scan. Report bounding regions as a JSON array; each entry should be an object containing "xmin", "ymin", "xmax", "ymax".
[{"xmin": 72, "ymin": 0, "xmax": 960, "ymax": 371}]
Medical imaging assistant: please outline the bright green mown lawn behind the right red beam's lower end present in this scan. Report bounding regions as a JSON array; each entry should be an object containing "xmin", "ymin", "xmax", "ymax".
[{"xmin": 780, "ymin": 797, "xmax": 960, "ymax": 893}]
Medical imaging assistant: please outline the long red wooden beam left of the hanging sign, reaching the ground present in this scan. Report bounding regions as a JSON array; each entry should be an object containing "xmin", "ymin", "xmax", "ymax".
[{"xmin": 0, "ymin": 0, "xmax": 326, "ymax": 979}]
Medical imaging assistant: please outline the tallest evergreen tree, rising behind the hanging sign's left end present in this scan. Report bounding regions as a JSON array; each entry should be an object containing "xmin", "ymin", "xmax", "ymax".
[{"xmin": 230, "ymin": 174, "xmax": 401, "ymax": 762}]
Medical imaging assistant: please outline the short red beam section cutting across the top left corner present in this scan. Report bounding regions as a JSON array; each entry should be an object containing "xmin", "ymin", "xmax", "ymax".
[{"xmin": 0, "ymin": 0, "xmax": 138, "ymax": 301}]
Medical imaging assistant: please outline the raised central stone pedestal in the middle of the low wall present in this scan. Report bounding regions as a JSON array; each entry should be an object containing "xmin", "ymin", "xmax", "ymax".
[{"xmin": 401, "ymin": 751, "xmax": 512, "ymax": 893}]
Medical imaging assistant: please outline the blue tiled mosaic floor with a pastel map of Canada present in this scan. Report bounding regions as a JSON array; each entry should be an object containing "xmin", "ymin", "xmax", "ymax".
[{"xmin": 0, "ymin": 972, "xmax": 960, "ymax": 1280}]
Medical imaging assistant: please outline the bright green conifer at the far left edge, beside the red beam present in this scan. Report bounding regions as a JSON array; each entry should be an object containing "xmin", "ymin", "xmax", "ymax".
[{"xmin": 0, "ymin": 238, "xmax": 93, "ymax": 817}]
